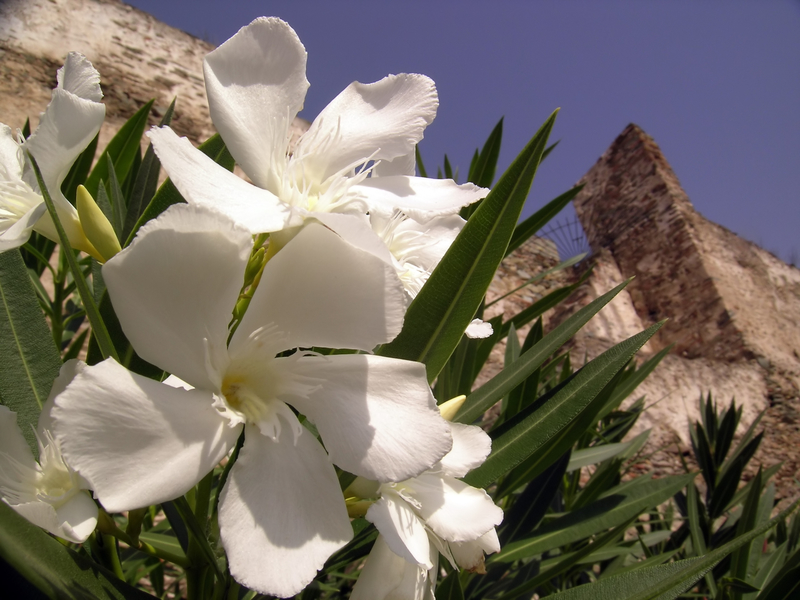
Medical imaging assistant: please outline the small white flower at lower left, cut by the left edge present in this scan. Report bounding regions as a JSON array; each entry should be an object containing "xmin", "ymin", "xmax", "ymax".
[{"xmin": 0, "ymin": 361, "xmax": 97, "ymax": 542}]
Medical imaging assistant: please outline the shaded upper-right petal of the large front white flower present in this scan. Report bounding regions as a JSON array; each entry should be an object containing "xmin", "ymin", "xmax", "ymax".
[{"xmin": 230, "ymin": 223, "xmax": 406, "ymax": 353}]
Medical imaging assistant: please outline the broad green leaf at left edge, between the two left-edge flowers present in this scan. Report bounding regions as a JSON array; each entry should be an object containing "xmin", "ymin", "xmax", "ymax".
[{"xmin": 0, "ymin": 250, "xmax": 61, "ymax": 457}]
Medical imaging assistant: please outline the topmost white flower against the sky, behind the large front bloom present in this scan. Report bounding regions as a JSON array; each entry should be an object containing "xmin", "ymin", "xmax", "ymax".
[{"xmin": 148, "ymin": 18, "xmax": 487, "ymax": 244}]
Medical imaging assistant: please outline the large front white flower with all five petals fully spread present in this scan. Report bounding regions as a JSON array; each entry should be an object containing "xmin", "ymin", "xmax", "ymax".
[{"xmin": 54, "ymin": 204, "xmax": 452, "ymax": 596}]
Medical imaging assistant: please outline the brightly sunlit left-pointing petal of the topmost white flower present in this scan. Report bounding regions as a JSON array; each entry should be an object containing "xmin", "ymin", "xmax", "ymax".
[{"xmin": 147, "ymin": 127, "xmax": 289, "ymax": 234}]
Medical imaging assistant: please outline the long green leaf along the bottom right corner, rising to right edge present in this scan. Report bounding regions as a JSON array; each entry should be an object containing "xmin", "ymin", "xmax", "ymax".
[{"xmin": 549, "ymin": 502, "xmax": 800, "ymax": 600}]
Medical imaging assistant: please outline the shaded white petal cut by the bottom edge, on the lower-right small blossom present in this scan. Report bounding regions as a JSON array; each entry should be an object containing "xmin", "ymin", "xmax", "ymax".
[{"xmin": 350, "ymin": 535, "xmax": 428, "ymax": 600}]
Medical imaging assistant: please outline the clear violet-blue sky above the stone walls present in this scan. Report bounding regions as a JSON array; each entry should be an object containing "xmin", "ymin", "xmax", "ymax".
[{"xmin": 129, "ymin": 0, "xmax": 800, "ymax": 264}]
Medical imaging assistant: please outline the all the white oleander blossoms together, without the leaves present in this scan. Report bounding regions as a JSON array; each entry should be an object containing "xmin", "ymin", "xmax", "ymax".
[{"xmin": 0, "ymin": 18, "xmax": 502, "ymax": 599}]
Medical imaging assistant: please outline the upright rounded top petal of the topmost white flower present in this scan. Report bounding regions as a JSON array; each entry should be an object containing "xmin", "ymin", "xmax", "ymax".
[{"xmin": 203, "ymin": 17, "xmax": 308, "ymax": 189}]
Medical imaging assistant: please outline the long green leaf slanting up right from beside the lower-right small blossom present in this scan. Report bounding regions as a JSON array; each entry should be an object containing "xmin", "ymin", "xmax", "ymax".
[{"xmin": 464, "ymin": 323, "xmax": 662, "ymax": 487}]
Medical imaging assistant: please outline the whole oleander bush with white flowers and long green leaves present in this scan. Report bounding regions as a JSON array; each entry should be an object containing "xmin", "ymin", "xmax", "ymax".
[{"xmin": 0, "ymin": 18, "xmax": 800, "ymax": 600}]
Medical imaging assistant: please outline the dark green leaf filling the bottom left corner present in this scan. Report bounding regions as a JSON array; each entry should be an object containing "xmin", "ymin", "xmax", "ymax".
[{"xmin": 0, "ymin": 502, "xmax": 154, "ymax": 600}]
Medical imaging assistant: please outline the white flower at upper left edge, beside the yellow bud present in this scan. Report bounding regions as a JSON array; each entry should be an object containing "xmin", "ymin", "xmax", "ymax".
[{"xmin": 0, "ymin": 52, "xmax": 106, "ymax": 258}]
